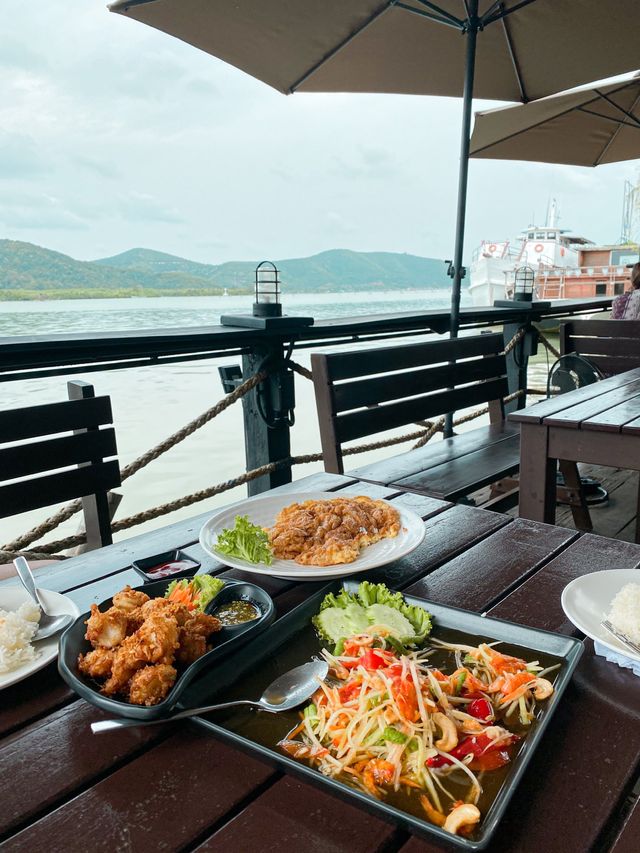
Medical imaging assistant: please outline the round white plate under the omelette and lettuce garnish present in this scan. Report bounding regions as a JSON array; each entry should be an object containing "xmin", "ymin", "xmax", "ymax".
[{"xmin": 200, "ymin": 492, "xmax": 424, "ymax": 580}]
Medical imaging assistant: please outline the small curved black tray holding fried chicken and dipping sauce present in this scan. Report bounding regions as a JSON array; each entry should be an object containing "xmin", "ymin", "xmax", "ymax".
[{"xmin": 58, "ymin": 578, "xmax": 275, "ymax": 720}]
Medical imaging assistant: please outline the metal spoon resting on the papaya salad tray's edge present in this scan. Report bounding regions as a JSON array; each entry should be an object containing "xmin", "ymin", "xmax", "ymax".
[{"xmin": 91, "ymin": 660, "xmax": 329, "ymax": 735}]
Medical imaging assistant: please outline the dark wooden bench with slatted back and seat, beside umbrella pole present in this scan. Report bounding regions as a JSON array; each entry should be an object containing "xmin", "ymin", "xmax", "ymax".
[{"xmin": 311, "ymin": 333, "xmax": 520, "ymax": 502}]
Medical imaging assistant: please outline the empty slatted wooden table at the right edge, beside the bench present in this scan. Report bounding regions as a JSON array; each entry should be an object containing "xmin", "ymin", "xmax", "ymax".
[{"xmin": 509, "ymin": 368, "xmax": 640, "ymax": 541}]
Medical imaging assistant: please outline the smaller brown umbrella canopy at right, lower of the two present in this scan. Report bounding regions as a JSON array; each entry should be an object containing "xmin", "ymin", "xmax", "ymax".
[{"xmin": 470, "ymin": 75, "xmax": 640, "ymax": 166}]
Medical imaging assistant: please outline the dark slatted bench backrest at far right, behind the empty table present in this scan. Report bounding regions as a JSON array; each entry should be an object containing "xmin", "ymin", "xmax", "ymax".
[{"xmin": 560, "ymin": 320, "xmax": 640, "ymax": 376}]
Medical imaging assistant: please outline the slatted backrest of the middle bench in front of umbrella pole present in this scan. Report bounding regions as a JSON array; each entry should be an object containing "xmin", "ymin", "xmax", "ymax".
[{"xmin": 311, "ymin": 333, "xmax": 508, "ymax": 474}]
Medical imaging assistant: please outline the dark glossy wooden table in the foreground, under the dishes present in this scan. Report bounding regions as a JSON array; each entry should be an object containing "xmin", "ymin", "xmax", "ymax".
[{"xmin": 0, "ymin": 474, "xmax": 640, "ymax": 853}]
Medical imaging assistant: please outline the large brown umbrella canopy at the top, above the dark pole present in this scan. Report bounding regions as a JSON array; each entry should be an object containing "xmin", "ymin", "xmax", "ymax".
[{"xmin": 109, "ymin": 0, "xmax": 639, "ymax": 102}]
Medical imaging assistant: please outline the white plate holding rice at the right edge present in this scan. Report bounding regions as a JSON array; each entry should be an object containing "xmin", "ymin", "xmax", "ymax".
[{"xmin": 561, "ymin": 569, "xmax": 640, "ymax": 661}]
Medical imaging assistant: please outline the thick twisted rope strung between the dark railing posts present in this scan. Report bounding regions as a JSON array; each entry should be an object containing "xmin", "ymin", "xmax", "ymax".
[{"xmin": 0, "ymin": 327, "xmax": 532, "ymax": 562}]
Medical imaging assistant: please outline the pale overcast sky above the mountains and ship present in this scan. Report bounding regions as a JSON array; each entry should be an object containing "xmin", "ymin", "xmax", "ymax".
[{"xmin": 0, "ymin": 0, "xmax": 638, "ymax": 263}]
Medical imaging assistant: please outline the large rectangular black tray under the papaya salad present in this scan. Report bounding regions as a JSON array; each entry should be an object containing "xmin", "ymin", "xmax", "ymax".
[{"xmin": 182, "ymin": 581, "xmax": 583, "ymax": 850}]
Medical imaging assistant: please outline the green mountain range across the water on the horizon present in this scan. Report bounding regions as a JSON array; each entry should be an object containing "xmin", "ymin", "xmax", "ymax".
[{"xmin": 0, "ymin": 240, "xmax": 450, "ymax": 299}]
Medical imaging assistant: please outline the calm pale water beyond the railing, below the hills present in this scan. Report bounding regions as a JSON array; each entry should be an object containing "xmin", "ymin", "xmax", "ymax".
[{"xmin": 0, "ymin": 290, "xmax": 468, "ymax": 544}]
